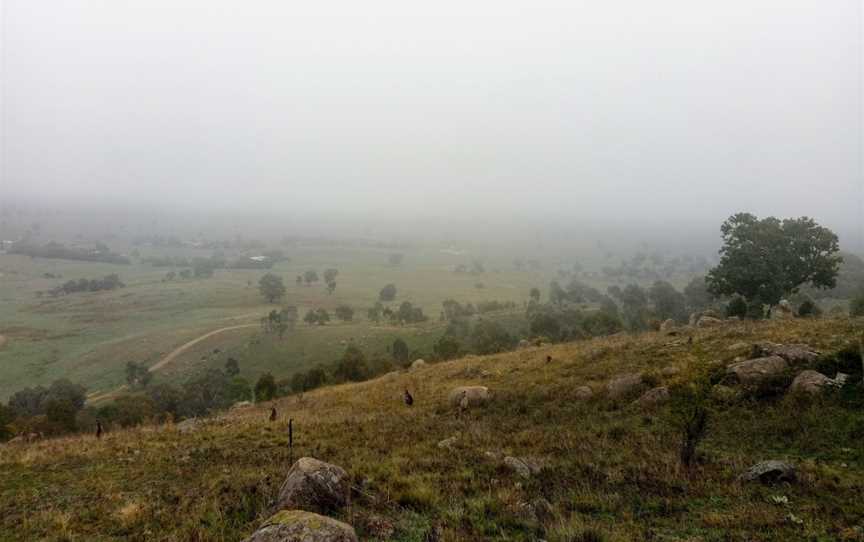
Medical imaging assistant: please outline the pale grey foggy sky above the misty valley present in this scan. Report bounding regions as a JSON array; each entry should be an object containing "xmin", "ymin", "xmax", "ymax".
[{"xmin": 0, "ymin": 0, "xmax": 861, "ymax": 236}]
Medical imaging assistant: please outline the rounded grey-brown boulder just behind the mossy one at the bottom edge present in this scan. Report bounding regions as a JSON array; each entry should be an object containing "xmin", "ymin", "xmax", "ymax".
[{"xmin": 277, "ymin": 457, "xmax": 351, "ymax": 513}]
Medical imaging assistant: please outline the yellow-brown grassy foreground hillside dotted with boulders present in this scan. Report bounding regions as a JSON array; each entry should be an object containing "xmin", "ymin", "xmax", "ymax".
[{"xmin": 0, "ymin": 319, "xmax": 864, "ymax": 541}]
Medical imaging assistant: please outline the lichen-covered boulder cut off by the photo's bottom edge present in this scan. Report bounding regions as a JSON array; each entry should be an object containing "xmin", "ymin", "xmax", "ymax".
[{"xmin": 245, "ymin": 510, "xmax": 357, "ymax": 542}]
